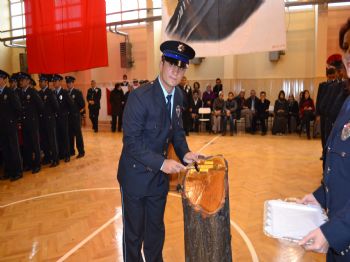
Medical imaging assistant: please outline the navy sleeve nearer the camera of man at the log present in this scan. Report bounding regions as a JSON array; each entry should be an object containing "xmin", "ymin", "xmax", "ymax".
[{"xmin": 123, "ymin": 92, "xmax": 165, "ymax": 173}]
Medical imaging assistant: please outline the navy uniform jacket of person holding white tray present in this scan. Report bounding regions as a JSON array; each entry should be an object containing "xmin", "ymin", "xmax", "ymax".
[{"xmin": 314, "ymin": 94, "xmax": 350, "ymax": 261}]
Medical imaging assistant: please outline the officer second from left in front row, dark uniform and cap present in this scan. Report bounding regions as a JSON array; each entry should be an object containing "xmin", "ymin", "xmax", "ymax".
[{"xmin": 18, "ymin": 72, "xmax": 44, "ymax": 174}]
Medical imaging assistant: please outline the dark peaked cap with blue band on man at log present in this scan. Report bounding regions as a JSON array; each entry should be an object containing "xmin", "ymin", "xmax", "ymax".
[{"xmin": 160, "ymin": 40, "xmax": 196, "ymax": 68}]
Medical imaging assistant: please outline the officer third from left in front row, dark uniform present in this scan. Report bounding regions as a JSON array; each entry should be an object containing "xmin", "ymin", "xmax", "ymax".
[{"xmin": 39, "ymin": 74, "xmax": 59, "ymax": 167}]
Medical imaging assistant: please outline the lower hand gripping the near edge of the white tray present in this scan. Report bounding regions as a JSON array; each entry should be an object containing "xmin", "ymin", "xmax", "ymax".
[{"xmin": 299, "ymin": 228, "xmax": 329, "ymax": 253}]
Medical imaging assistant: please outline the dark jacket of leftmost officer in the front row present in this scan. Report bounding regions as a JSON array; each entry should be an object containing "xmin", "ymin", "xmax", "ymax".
[{"xmin": 0, "ymin": 87, "xmax": 22, "ymax": 132}]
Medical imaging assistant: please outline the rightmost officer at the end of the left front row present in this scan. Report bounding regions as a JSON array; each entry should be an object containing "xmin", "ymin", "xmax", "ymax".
[{"xmin": 65, "ymin": 76, "xmax": 85, "ymax": 158}]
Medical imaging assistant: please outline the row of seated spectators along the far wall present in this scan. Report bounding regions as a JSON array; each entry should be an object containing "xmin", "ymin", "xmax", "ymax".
[{"xmin": 189, "ymin": 90, "xmax": 315, "ymax": 138}]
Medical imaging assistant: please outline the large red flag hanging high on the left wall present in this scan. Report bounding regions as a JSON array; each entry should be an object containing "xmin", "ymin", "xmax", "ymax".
[{"xmin": 24, "ymin": 0, "xmax": 108, "ymax": 73}]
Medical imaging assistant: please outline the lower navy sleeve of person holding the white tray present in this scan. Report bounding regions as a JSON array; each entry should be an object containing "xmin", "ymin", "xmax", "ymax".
[{"xmin": 321, "ymin": 200, "xmax": 350, "ymax": 254}]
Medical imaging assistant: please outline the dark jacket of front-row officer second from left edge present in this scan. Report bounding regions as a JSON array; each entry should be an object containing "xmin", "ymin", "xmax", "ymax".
[{"xmin": 21, "ymin": 87, "xmax": 44, "ymax": 128}]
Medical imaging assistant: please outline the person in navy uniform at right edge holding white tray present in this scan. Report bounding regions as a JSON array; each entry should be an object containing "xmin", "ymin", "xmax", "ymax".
[{"xmin": 299, "ymin": 19, "xmax": 350, "ymax": 262}]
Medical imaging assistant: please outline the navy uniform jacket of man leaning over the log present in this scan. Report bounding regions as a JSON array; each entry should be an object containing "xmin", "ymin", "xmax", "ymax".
[{"xmin": 118, "ymin": 79, "xmax": 190, "ymax": 196}]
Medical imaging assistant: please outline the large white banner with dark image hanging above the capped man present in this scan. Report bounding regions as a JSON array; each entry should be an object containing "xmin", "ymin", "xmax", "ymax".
[{"xmin": 162, "ymin": 0, "xmax": 286, "ymax": 57}]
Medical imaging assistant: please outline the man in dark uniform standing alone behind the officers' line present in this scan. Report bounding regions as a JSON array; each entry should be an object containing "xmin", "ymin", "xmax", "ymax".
[{"xmin": 86, "ymin": 80, "xmax": 101, "ymax": 133}]
